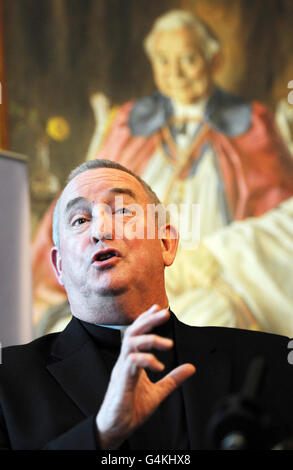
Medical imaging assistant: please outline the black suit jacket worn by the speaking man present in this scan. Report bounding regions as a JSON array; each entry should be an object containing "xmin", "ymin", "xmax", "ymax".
[{"xmin": 0, "ymin": 315, "xmax": 293, "ymax": 450}]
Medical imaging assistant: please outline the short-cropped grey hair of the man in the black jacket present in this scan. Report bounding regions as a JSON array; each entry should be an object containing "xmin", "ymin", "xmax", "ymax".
[{"xmin": 52, "ymin": 158, "xmax": 161, "ymax": 248}]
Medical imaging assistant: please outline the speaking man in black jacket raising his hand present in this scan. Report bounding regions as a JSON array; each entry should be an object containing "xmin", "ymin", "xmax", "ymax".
[{"xmin": 0, "ymin": 160, "xmax": 293, "ymax": 450}]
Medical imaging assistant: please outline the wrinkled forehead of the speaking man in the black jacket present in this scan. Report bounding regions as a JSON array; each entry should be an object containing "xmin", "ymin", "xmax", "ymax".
[{"xmin": 60, "ymin": 168, "xmax": 147, "ymax": 211}]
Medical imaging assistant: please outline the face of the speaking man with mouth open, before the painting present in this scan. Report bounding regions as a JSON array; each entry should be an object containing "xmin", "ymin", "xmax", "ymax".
[{"xmin": 53, "ymin": 168, "xmax": 175, "ymax": 323}]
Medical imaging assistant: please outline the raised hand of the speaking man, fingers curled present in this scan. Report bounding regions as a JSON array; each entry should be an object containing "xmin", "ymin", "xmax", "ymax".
[{"xmin": 96, "ymin": 305, "xmax": 195, "ymax": 449}]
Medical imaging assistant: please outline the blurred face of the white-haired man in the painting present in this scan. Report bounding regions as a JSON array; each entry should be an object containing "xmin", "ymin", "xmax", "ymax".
[{"xmin": 152, "ymin": 29, "xmax": 212, "ymax": 104}]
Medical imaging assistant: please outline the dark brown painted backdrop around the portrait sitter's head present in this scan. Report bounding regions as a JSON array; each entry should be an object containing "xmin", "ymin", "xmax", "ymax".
[{"xmin": 0, "ymin": 0, "xmax": 293, "ymax": 234}]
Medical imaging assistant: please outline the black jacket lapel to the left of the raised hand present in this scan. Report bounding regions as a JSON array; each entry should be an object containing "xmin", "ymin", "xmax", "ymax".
[{"xmin": 47, "ymin": 318, "xmax": 109, "ymax": 416}]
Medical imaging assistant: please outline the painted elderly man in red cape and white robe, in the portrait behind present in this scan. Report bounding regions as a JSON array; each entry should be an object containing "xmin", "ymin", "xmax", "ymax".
[{"xmin": 35, "ymin": 10, "xmax": 293, "ymax": 329}]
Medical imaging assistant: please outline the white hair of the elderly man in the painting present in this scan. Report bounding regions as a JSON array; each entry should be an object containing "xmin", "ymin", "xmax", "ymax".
[{"xmin": 143, "ymin": 10, "xmax": 220, "ymax": 61}]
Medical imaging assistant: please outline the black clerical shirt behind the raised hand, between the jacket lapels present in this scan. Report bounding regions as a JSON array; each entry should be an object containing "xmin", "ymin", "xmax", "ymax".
[{"xmin": 80, "ymin": 317, "xmax": 190, "ymax": 450}]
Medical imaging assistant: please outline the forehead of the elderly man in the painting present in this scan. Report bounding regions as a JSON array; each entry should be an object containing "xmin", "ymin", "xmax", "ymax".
[{"xmin": 154, "ymin": 28, "xmax": 199, "ymax": 55}]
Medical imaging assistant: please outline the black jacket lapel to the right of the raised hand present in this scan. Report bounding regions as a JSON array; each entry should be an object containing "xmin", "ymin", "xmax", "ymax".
[{"xmin": 175, "ymin": 319, "xmax": 231, "ymax": 449}]
